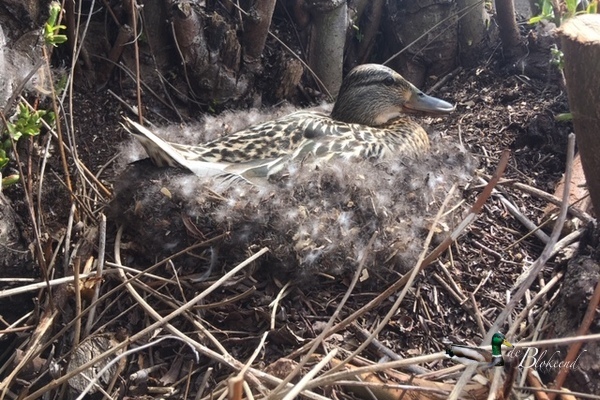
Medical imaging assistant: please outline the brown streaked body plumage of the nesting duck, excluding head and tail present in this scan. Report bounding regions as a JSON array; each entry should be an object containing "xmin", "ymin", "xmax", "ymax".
[{"xmin": 169, "ymin": 111, "xmax": 429, "ymax": 163}]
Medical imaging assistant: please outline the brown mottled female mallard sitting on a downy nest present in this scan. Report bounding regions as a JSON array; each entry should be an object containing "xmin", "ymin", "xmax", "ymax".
[{"xmin": 127, "ymin": 64, "xmax": 454, "ymax": 178}]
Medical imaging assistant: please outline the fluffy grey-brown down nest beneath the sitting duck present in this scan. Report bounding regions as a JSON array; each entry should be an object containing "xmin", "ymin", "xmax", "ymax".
[{"xmin": 108, "ymin": 138, "xmax": 475, "ymax": 282}]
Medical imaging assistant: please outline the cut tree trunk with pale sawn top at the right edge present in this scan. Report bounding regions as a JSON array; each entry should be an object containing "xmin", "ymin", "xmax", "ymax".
[{"xmin": 561, "ymin": 14, "xmax": 600, "ymax": 216}]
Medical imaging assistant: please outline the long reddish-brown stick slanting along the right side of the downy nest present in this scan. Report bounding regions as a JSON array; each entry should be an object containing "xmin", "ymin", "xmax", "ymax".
[{"xmin": 288, "ymin": 151, "xmax": 510, "ymax": 358}]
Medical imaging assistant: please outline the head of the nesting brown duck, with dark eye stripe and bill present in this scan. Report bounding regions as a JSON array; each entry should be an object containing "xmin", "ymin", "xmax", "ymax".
[{"xmin": 331, "ymin": 64, "xmax": 455, "ymax": 126}]
